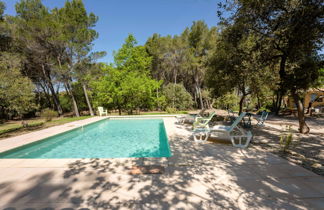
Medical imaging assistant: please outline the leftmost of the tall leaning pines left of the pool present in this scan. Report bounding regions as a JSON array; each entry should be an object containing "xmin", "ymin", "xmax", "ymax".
[{"xmin": 12, "ymin": 0, "xmax": 63, "ymax": 115}]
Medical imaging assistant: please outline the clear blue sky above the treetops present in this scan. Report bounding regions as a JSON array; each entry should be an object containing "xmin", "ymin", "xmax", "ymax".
[{"xmin": 3, "ymin": 0, "xmax": 221, "ymax": 62}]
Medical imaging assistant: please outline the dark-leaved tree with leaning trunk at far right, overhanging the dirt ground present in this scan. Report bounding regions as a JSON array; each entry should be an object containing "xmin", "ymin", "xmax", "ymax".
[{"xmin": 219, "ymin": 0, "xmax": 324, "ymax": 133}]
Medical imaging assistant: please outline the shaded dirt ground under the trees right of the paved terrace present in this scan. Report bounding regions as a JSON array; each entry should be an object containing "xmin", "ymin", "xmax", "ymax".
[{"xmin": 204, "ymin": 110, "xmax": 324, "ymax": 176}]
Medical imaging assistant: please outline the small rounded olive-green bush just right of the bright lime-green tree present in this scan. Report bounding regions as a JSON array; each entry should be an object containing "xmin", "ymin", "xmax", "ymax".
[{"xmin": 163, "ymin": 83, "xmax": 193, "ymax": 110}]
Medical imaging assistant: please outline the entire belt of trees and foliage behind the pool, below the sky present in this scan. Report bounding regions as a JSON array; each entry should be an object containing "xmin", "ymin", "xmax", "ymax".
[{"xmin": 0, "ymin": 0, "xmax": 324, "ymax": 121}]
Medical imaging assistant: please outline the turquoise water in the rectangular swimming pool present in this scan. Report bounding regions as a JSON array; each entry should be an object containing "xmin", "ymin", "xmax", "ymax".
[{"xmin": 0, "ymin": 119, "xmax": 171, "ymax": 159}]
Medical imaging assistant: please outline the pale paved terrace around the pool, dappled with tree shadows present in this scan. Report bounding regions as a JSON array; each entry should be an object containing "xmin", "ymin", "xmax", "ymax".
[{"xmin": 0, "ymin": 115, "xmax": 324, "ymax": 209}]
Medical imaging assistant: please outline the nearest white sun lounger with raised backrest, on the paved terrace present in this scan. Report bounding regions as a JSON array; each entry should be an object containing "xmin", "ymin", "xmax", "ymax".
[{"xmin": 193, "ymin": 112, "xmax": 252, "ymax": 148}]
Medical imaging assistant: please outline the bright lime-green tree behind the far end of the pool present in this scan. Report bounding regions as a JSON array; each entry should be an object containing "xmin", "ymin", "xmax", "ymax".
[{"xmin": 91, "ymin": 34, "xmax": 162, "ymax": 114}]
